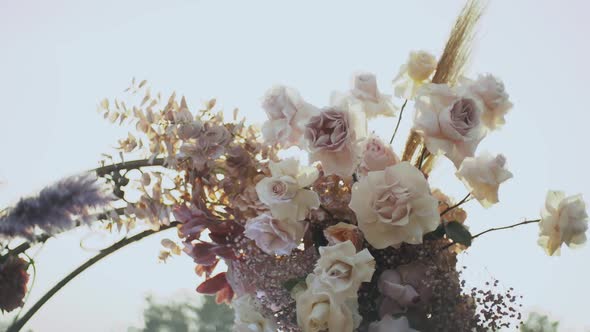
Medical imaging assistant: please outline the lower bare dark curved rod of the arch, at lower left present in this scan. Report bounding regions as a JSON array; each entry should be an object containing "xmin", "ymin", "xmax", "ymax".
[{"xmin": 6, "ymin": 222, "xmax": 180, "ymax": 332}]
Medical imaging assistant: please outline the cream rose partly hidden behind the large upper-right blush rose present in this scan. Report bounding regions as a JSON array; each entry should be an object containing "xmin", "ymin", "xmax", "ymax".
[{"xmin": 469, "ymin": 74, "xmax": 512, "ymax": 130}]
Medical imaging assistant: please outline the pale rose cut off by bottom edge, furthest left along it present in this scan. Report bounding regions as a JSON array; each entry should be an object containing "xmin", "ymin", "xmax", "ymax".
[{"xmin": 232, "ymin": 295, "xmax": 277, "ymax": 332}]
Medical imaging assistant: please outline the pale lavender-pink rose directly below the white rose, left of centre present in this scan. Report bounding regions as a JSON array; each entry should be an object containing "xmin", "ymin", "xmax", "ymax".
[{"xmin": 244, "ymin": 214, "xmax": 305, "ymax": 255}]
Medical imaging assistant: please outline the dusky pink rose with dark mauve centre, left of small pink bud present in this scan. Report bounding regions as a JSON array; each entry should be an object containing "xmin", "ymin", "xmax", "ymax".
[{"xmin": 305, "ymin": 108, "xmax": 356, "ymax": 178}]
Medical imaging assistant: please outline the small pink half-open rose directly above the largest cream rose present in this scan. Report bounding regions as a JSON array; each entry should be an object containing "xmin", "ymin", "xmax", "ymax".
[{"xmin": 359, "ymin": 135, "xmax": 400, "ymax": 175}]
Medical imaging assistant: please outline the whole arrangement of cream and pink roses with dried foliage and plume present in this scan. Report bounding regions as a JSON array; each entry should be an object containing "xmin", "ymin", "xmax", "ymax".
[{"xmin": 0, "ymin": 1, "xmax": 588, "ymax": 332}]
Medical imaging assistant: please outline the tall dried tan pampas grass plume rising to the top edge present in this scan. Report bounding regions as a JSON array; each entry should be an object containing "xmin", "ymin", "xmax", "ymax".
[{"xmin": 402, "ymin": 0, "xmax": 485, "ymax": 168}]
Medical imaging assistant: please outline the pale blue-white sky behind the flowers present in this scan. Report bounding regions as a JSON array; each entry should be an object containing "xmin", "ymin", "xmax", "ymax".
[{"xmin": 0, "ymin": 0, "xmax": 590, "ymax": 331}]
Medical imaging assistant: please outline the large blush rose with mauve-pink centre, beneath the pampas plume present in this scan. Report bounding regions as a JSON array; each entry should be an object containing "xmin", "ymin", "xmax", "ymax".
[{"xmin": 414, "ymin": 84, "xmax": 486, "ymax": 168}]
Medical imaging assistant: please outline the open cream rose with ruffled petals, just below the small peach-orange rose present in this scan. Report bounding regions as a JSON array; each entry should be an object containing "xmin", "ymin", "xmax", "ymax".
[{"xmin": 314, "ymin": 241, "xmax": 375, "ymax": 297}]
